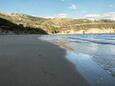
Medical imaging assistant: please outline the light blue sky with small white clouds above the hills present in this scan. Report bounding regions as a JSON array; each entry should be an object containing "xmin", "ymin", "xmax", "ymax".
[{"xmin": 0, "ymin": 0, "xmax": 115, "ymax": 18}]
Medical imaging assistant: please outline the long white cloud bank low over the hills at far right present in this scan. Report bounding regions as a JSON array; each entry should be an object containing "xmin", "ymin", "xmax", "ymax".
[{"xmin": 83, "ymin": 12, "xmax": 115, "ymax": 20}]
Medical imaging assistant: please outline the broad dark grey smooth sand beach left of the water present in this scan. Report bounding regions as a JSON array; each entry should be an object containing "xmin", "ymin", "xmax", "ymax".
[{"xmin": 0, "ymin": 35, "xmax": 90, "ymax": 86}]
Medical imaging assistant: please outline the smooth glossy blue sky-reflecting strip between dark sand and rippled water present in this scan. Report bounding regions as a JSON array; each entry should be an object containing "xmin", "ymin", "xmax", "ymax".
[{"xmin": 66, "ymin": 51, "xmax": 115, "ymax": 86}]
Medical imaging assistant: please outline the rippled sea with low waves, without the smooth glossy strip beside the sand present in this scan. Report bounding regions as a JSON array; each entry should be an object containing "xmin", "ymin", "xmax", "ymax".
[{"xmin": 41, "ymin": 34, "xmax": 115, "ymax": 77}]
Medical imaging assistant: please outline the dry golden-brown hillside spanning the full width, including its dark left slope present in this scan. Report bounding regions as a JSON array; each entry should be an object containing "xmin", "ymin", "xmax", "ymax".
[{"xmin": 0, "ymin": 13, "xmax": 115, "ymax": 34}]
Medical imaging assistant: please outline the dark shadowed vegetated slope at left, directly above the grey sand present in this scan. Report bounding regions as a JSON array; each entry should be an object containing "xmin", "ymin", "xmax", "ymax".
[{"xmin": 0, "ymin": 18, "xmax": 47, "ymax": 34}]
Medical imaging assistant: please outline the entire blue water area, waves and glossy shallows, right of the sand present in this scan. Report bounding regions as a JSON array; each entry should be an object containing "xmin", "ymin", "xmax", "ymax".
[{"xmin": 41, "ymin": 34, "xmax": 115, "ymax": 86}]
